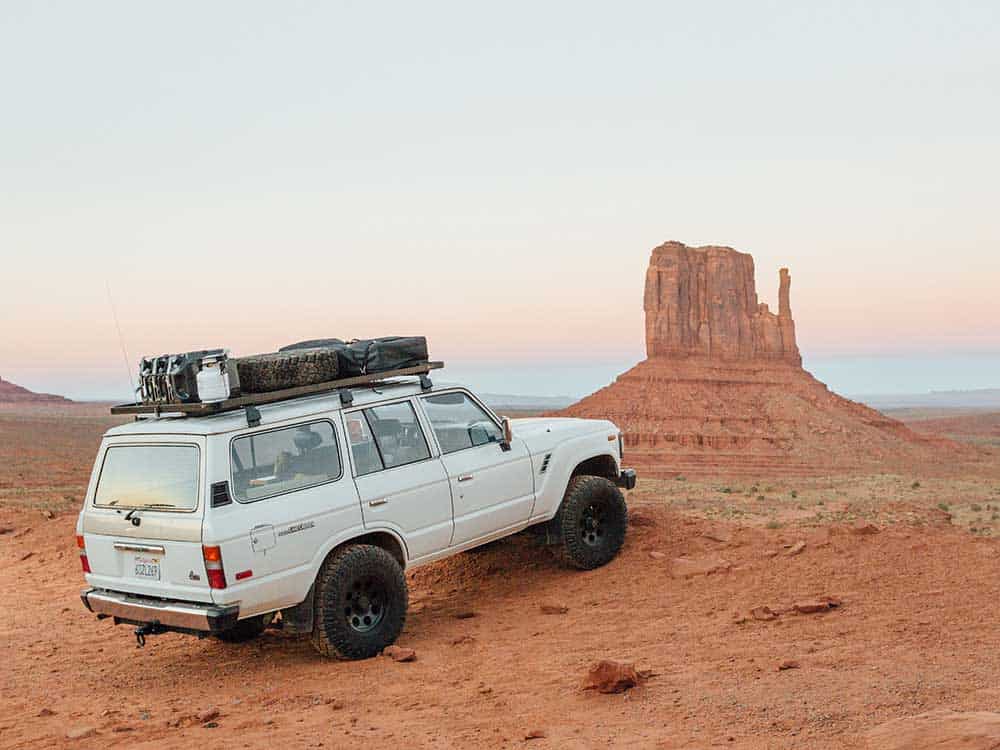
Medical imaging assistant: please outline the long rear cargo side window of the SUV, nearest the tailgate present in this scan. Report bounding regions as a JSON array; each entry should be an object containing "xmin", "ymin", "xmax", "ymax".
[{"xmin": 232, "ymin": 421, "xmax": 340, "ymax": 503}]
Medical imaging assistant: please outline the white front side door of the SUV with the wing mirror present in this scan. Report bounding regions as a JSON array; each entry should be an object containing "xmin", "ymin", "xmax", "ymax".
[{"xmin": 420, "ymin": 390, "xmax": 535, "ymax": 544}]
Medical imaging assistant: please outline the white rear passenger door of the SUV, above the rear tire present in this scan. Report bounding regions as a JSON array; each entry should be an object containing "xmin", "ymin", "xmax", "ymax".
[{"xmin": 344, "ymin": 399, "xmax": 453, "ymax": 560}]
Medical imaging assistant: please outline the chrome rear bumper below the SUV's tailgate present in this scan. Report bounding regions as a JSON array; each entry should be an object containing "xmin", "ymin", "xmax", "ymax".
[{"xmin": 80, "ymin": 589, "xmax": 240, "ymax": 633}]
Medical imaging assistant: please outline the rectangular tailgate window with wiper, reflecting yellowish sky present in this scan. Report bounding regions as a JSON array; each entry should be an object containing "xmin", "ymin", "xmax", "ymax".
[{"xmin": 94, "ymin": 445, "xmax": 200, "ymax": 510}]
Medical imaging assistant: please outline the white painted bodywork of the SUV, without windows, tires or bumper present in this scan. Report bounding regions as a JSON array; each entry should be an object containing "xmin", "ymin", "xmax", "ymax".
[{"xmin": 78, "ymin": 383, "xmax": 621, "ymax": 618}]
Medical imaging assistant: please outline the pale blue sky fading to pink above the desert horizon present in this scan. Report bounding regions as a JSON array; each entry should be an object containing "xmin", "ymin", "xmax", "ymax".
[{"xmin": 0, "ymin": 2, "xmax": 1000, "ymax": 400}]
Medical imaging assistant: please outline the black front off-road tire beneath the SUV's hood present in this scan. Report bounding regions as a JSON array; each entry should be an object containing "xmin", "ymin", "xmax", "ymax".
[{"xmin": 556, "ymin": 476, "xmax": 628, "ymax": 570}]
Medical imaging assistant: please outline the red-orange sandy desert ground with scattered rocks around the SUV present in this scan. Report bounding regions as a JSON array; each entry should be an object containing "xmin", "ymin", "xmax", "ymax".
[{"xmin": 0, "ymin": 407, "xmax": 1000, "ymax": 748}]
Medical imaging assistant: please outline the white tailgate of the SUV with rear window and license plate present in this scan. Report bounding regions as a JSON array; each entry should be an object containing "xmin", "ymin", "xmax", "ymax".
[{"xmin": 83, "ymin": 435, "xmax": 211, "ymax": 602}]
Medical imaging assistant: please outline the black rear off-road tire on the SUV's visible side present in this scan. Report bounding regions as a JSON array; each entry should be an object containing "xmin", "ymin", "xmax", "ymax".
[{"xmin": 312, "ymin": 544, "xmax": 409, "ymax": 659}]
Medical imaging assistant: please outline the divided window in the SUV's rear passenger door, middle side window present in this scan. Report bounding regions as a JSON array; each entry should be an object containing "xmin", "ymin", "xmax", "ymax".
[{"xmin": 347, "ymin": 401, "xmax": 431, "ymax": 476}]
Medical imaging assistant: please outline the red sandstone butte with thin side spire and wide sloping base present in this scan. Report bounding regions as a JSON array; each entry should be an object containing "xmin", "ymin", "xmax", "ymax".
[{"xmin": 561, "ymin": 242, "xmax": 971, "ymax": 476}]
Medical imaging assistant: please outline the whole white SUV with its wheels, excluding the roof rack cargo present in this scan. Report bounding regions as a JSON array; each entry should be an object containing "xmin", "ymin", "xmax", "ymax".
[{"xmin": 77, "ymin": 379, "xmax": 635, "ymax": 658}]
